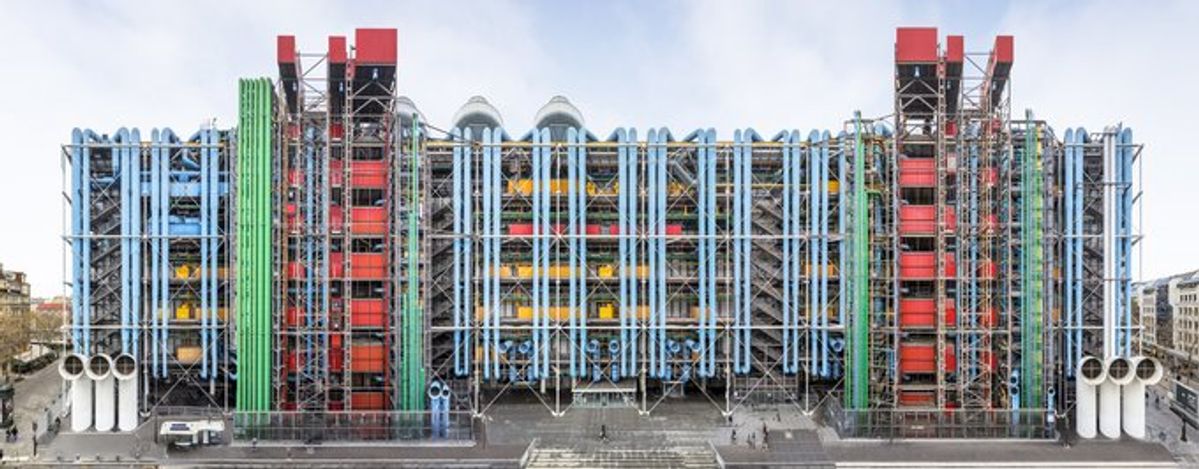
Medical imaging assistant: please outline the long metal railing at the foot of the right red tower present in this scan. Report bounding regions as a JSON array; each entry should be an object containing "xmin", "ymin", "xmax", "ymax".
[{"xmin": 821, "ymin": 401, "xmax": 1055, "ymax": 439}]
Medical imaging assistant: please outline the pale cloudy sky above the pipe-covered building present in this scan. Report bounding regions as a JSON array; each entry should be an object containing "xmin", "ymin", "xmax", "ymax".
[{"xmin": 0, "ymin": 0, "xmax": 1199, "ymax": 296}]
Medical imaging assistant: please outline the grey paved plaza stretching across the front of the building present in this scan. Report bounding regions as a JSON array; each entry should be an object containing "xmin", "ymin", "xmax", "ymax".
[{"xmin": 10, "ymin": 383, "xmax": 1199, "ymax": 468}]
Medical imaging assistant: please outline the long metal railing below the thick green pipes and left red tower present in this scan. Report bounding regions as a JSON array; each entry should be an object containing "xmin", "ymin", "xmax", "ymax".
[{"xmin": 233, "ymin": 410, "xmax": 475, "ymax": 443}]
